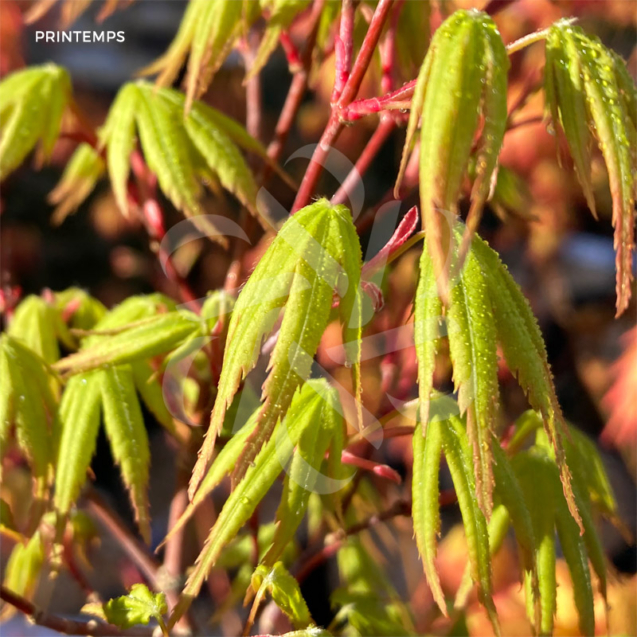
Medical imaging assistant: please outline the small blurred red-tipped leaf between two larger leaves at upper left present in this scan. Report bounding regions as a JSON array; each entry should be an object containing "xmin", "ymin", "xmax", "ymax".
[{"xmin": 48, "ymin": 143, "xmax": 105, "ymax": 224}]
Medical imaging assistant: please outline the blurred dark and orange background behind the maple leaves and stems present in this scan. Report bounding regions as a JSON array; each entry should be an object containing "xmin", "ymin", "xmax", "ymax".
[{"xmin": 0, "ymin": 0, "xmax": 637, "ymax": 635}]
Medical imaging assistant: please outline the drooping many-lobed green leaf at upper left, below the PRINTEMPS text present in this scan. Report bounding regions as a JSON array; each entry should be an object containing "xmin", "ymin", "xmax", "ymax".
[{"xmin": 100, "ymin": 83, "xmax": 267, "ymax": 224}]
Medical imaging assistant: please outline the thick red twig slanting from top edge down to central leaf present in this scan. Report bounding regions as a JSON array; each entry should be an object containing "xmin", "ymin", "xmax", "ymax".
[{"xmin": 292, "ymin": 0, "xmax": 394, "ymax": 213}]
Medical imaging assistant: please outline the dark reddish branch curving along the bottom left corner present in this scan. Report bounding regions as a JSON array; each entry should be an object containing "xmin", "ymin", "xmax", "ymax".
[{"xmin": 0, "ymin": 586, "xmax": 154, "ymax": 637}]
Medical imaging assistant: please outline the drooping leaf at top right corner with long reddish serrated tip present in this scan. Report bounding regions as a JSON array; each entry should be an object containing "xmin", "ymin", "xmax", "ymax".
[{"xmin": 545, "ymin": 20, "xmax": 637, "ymax": 316}]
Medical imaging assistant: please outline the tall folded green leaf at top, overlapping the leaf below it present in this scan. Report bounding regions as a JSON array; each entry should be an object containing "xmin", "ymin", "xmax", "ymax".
[{"xmin": 396, "ymin": 10, "xmax": 509, "ymax": 301}]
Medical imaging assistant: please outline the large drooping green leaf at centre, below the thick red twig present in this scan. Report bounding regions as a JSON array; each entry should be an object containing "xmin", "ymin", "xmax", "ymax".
[{"xmin": 189, "ymin": 199, "xmax": 361, "ymax": 499}]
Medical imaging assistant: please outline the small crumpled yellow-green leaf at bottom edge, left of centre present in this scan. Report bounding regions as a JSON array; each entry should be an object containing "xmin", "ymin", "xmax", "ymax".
[{"xmin": 252, "ymin": 562, "xmax": 314, "ymax": 628}]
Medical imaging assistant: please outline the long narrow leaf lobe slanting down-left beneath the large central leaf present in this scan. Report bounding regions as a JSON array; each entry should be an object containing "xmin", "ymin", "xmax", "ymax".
[{"xmin": 170, "ymin": 380, "xmax": 336, "ymax": 627}]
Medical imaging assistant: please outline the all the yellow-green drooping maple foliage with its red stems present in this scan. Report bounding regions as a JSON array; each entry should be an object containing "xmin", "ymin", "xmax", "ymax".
[{"xmin": 0, "ymin": 0, "xmax": 637, "ymax": 636}]
